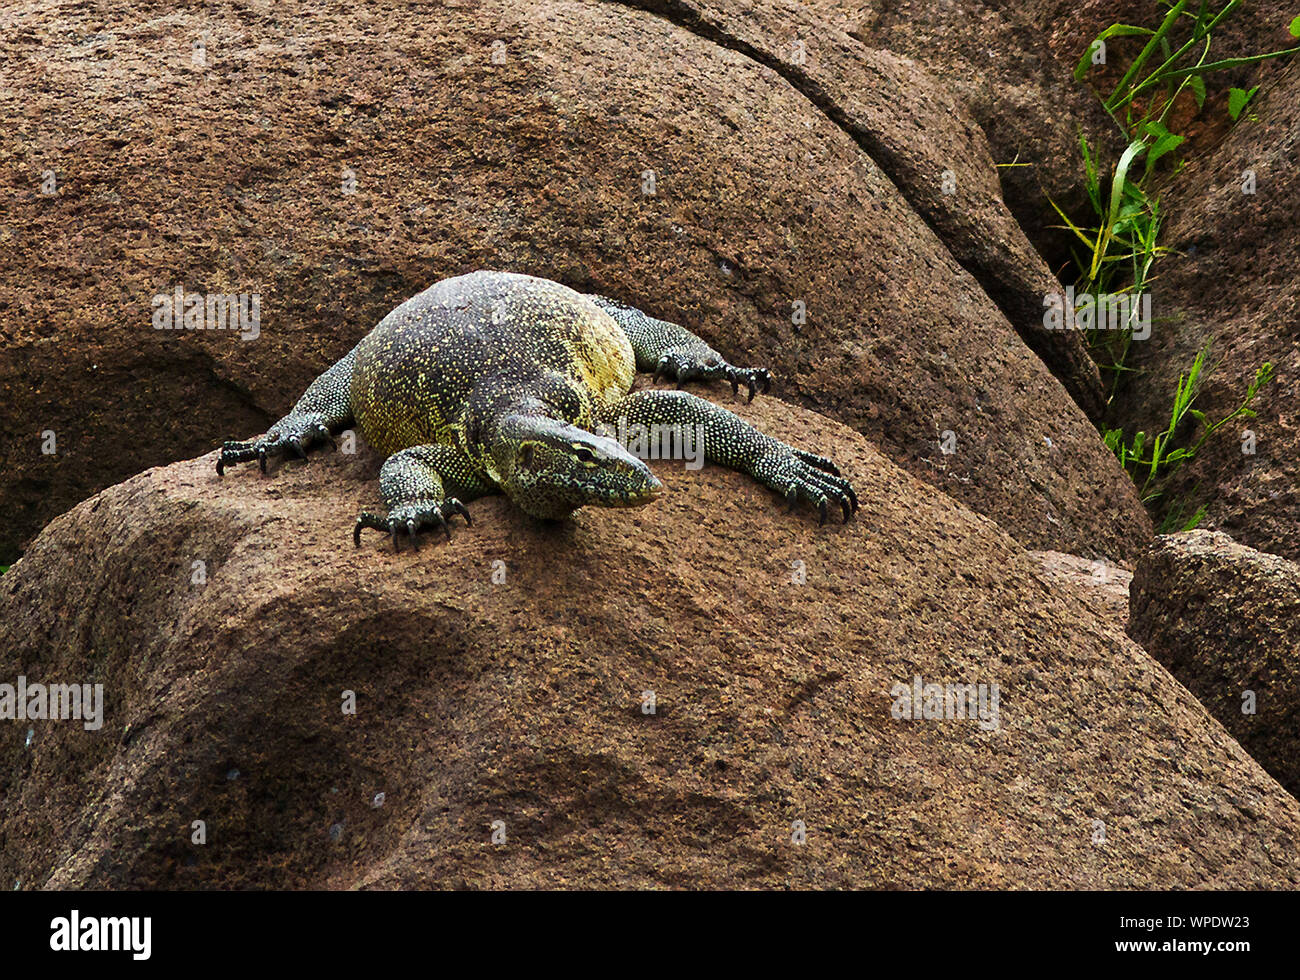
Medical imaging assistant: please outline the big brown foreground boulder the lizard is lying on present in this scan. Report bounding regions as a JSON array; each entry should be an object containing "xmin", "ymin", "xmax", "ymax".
[{"xmin": 0, "ymin": 399, "xmax": 1300, "ymax": 888}]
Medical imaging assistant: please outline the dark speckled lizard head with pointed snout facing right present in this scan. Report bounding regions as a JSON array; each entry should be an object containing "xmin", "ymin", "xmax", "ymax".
[{"xmin": 491, "ymin": 415, "xmax": 663, "ymax": 519}]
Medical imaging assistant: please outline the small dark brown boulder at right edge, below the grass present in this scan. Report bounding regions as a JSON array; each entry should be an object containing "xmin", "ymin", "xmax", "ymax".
[{"xmin": 1128, "ymin": 530, "xmax": 1300, "ymax": 794}]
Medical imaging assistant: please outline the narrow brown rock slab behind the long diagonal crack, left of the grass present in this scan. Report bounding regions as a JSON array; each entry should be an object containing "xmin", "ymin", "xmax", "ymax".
[{"xmin": 613, "ymin": 0, "xmax": 1104, "ymax": 419}]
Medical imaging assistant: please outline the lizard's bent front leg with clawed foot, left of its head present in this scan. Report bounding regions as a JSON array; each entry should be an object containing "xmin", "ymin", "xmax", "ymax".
[{"xmin": 352, "ymin": 445, "xmax": 493, "ymax": 550}]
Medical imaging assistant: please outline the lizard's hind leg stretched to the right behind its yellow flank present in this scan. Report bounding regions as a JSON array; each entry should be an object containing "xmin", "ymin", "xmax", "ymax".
[{"xmin": 588, "ymin": 295, "xmax": 772, "ymax": 402}]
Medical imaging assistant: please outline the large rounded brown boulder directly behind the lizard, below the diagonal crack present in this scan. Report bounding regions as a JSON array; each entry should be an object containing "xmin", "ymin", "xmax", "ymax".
[{"xmin": 0, "ymin": 0, "xmax": 1149, "ymax": 560}]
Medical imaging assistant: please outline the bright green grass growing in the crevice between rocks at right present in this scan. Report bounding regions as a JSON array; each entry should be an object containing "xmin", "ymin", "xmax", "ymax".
[{"xmin": 1052, "ymin": 0, "xmax": 1300, "ymax": 533}]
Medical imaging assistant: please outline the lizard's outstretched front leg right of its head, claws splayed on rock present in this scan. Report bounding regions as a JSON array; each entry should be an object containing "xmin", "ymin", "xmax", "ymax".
[{"xmin": 612, "ymin": 389, "xmax": 858, "ymax": 524}]
